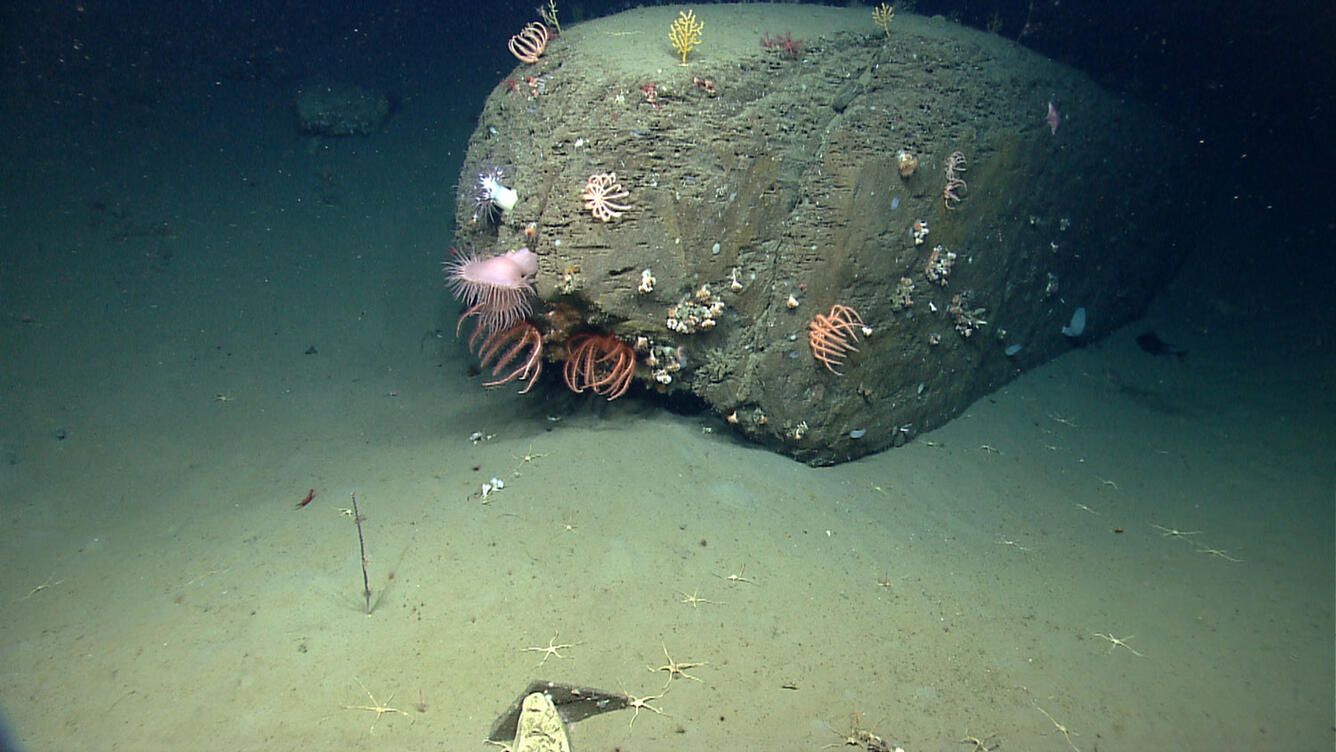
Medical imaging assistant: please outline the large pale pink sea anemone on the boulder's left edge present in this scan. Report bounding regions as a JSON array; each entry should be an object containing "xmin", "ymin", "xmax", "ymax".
[{"xmin": 445, "ymin": 248, "xmax": 538, "ymax": 333}]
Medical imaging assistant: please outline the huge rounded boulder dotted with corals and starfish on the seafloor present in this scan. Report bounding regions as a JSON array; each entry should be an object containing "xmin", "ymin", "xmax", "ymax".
[{"xmin": 456, "ymin": 4, "xmax": 1185, "ymax": 463}]
